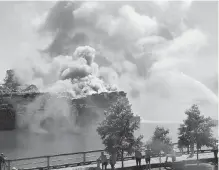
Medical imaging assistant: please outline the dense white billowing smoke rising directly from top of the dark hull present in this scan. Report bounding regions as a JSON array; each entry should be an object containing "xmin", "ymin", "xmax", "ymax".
[{"xmin": 16, "ymin": 46, "xmax": 117, "ymax": 98}]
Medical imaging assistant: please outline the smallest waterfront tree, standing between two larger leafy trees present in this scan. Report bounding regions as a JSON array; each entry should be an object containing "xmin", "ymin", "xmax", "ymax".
[{"xmin": 148, "ymin": 126, "xmax": 172, "ymax": 163}]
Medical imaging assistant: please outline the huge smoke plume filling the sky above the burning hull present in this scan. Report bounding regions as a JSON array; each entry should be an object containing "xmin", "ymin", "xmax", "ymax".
[{"xmin": 0, "ymin": 1, "xmax": 217, "ymax": 135}]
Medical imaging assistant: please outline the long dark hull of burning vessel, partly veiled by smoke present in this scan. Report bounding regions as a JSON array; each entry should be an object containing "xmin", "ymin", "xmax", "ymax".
[{"xmin": 0, "ymin": 91, "xmax": 126, "ymax": 130}]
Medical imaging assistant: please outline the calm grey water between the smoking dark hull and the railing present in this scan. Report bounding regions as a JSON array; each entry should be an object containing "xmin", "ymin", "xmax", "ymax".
[{"xmin": 0, "ymin": 131, "xmax": 103, "ymax": 159}]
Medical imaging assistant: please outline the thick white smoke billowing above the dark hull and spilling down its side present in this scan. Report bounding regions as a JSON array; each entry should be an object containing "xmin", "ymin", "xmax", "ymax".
[{"xmin": 16, "ymin": 46, "xmax": 117, "ymax": 133}]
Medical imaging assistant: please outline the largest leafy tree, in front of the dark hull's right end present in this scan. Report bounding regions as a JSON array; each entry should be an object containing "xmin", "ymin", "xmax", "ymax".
[{"xmin": 97, "ymin": 97, "xmax": 143, "ymax": 168}]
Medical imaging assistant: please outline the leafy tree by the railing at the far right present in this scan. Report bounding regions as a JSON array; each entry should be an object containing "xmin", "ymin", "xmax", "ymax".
[{"xmin": 178, "ymin": 104, "xmax": 215, "ymax": 160}]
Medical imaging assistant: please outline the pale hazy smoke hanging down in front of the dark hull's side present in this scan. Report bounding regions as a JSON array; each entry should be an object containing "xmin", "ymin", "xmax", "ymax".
[{"xmin": 17, "ymin": 94, "xmax": 77, "ymax": 133}]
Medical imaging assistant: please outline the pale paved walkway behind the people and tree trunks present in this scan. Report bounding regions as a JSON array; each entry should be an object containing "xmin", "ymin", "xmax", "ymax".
[{"xmin": 54, "ymin": 153, "xmax": 214, "ymax": 170}]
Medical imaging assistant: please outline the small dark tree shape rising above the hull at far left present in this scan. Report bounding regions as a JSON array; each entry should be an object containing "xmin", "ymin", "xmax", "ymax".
[{"xmin": 3, "ymin": 70, "xmax": 20, "ymax": 91}]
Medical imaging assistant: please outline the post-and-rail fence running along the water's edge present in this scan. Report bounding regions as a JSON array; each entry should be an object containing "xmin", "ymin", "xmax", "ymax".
[{"xmin": 5, "ymin": 150, "xmax": 215, "ymax": 170}]
